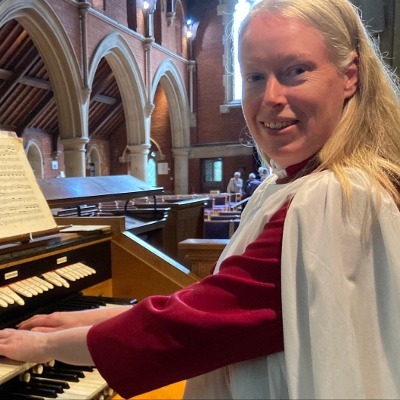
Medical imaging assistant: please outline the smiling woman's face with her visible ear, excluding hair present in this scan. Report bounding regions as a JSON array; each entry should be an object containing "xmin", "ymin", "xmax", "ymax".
[{"xmin": 240, "ymin": 12, "xmax": 358, "ymax": 167}]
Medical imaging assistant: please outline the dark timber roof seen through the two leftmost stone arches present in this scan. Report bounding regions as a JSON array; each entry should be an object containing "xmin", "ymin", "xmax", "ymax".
[{"xmin": 0, "ymin": 20, "xmax": 125, "ymax": 143}]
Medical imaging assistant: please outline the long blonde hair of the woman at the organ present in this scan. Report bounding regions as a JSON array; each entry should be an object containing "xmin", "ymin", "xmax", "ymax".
[{"xmin": 239, "ymin": 0, "xmax": 400, "ymax": 205}]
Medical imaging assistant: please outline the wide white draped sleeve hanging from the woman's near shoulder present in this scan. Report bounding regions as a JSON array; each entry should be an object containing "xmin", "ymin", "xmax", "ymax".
[{"xmin": 282, "ymin": 173, "xmax": 400, "ymax": 399}]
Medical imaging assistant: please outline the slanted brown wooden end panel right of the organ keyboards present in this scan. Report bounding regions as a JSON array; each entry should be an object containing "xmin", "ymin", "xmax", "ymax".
[{"xmin": 111, "ymin": 232, "xmax": 199, "ymax": 300}]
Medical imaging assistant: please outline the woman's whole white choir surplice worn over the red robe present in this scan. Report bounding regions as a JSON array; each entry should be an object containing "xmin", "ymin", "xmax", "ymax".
[{"xmin": 184, "ymin": 170, "xmax": 400, "ymax": 399}]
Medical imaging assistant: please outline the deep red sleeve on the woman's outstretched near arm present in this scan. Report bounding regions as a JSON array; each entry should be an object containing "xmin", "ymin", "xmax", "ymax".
[{"xmin": 88, "ymin": 206, "xmax": 287, "ymax": 397}]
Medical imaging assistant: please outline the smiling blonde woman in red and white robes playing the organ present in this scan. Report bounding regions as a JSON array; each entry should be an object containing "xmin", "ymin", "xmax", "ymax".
[{"xmin": 0, "ymin": 0, "xmax": 400, "ymax": 399}]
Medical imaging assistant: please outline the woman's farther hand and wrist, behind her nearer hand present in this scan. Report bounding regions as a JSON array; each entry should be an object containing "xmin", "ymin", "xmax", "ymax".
[{"xmin": 17, "ymin": 306, "xmax": 132, "ymax": 332}]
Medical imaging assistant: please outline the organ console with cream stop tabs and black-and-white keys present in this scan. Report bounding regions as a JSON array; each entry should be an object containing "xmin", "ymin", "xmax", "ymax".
[{"xmin": 0, "ymin": 228, "xmax": 120, "ymax": 400}]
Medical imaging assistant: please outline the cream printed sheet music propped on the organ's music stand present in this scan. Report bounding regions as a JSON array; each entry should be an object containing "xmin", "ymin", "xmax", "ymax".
[{"xmin": 0, "ymin": 132, "xmax": 57, "ymax": 239}]
